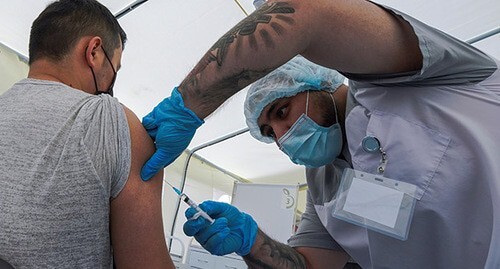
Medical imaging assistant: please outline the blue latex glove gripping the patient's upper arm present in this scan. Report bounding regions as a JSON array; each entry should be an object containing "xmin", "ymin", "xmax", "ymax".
[{"xmin": 141, "ymin": 87, "xmax": 204, "ymax": 181}]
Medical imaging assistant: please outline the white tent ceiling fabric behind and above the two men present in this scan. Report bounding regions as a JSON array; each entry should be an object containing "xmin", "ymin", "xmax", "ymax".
[{"xmin": 0, "ymin": 0, "xmax": 500, "ymax": 182}]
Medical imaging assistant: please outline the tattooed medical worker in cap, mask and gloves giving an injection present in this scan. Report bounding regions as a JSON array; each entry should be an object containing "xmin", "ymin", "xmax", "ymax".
[{"xmin": 142, "ymin": 0, "xmax": 500, "ymax": 268}]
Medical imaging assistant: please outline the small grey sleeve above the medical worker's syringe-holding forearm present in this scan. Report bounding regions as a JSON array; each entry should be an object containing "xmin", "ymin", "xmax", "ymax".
[{"xmin": 288, "ymin": 191, "xmax": 344, "ymax": 251}]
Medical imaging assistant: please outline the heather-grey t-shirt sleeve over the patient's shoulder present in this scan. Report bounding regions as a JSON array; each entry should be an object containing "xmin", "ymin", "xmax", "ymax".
[{"xmin": 80, "ymin": 94, "xmax": 131, "ymax": 198}]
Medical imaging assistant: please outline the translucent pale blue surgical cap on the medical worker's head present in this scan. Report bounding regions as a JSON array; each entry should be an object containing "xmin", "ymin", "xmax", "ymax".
[{"xmin": 245, "ymin": 56, "xmax": 344, "ymax": 143}]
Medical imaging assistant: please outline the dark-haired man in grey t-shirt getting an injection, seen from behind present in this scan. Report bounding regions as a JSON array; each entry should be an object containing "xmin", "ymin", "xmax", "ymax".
[{"xmin": 0, "ymin": 0, "xmax": 174, "ymax": 268}]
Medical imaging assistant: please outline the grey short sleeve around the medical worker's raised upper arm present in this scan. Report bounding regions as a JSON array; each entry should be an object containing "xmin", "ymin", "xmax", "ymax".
[{"xmin": 343, "ymin": 3, "xmax": 497, "ymax": 86}]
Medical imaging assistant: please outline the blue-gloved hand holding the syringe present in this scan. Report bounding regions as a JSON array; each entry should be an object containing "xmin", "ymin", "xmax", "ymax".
[{"xmin": 184, "ymin": 201, "xmax": 258, "ymax": 256}]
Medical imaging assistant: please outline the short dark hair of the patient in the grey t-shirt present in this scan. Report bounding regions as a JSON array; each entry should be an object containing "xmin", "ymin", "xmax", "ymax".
[{"xmin": 29, "ymin": 0, "xmax": 127, "ymax": 64}]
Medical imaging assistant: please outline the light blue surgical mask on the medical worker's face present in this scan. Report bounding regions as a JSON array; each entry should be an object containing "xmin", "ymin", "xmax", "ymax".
[{"xmin": 278, "ymin": 93, "xmax": 342, "ymax": 167}]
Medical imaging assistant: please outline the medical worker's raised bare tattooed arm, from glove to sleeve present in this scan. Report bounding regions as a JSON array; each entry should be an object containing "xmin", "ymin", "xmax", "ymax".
[{"xmin": 179, "ymin": 0, "xmax": 422, "ymax": 118}]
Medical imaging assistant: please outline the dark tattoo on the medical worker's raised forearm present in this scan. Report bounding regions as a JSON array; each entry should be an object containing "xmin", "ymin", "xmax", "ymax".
[{"xmin": 180, "ymin": 2, "xmax": 295, "ymax": 110}]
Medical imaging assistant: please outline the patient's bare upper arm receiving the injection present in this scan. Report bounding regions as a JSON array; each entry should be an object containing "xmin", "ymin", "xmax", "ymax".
[{"xmin": 111, "ymin": 105, "xmax": 175, "ymax": 269}]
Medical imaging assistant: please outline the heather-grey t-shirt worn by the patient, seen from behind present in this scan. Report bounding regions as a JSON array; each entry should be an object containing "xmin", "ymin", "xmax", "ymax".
[{"xmin": 0, "ymin": 79, "xmax": 131, "ymax": 268}]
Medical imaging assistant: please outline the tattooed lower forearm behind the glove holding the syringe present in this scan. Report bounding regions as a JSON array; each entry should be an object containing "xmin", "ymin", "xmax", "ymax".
[{"xmin": 243, "ymin": 229, "xmax": 349, "ymax": 269}]
